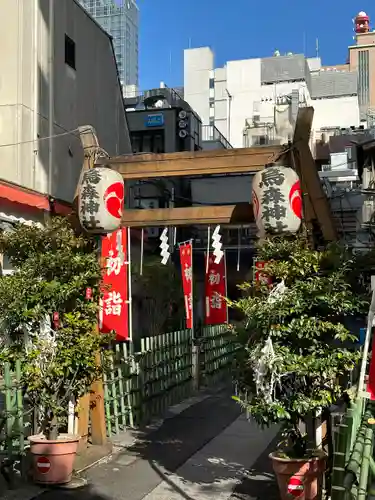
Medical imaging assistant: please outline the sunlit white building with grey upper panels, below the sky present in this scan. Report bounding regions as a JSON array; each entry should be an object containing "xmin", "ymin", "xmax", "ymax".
[{"xmin": 184, "ymin": 47, "xmax": 360, "ymax": 147}]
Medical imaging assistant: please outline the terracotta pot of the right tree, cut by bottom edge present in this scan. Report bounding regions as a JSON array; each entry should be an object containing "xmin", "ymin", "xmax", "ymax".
[{"xmin": 270, "ymin": 453, "xmax": 327, "ymax": 500}]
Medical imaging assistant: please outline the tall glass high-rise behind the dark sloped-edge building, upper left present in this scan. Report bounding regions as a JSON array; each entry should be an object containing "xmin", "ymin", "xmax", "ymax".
[{"xmin": 79, "ymin": 0, "xmax": 138, "ymax": 89}]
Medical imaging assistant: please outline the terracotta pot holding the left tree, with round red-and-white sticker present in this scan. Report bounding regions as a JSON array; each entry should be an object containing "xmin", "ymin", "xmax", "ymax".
[{"xmin": 29, "ymin": 434, "xmax": 79, "ymax": 485}]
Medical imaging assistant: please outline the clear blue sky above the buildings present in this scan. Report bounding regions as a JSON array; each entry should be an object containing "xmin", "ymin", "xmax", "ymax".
[{"xmin": 138, "ymin": 0, "xmax": 375, "ymax": 90}]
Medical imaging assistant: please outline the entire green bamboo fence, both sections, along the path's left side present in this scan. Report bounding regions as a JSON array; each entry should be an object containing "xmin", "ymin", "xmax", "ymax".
[{"xmin": 104, "ymin": 325, "xmax": 237, "ymax": 436}]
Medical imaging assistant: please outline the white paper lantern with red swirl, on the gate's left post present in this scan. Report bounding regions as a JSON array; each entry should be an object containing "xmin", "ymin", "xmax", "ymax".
[{"xmin": 78, "ymin": 167, "xmax": 125, "ymax": 234}]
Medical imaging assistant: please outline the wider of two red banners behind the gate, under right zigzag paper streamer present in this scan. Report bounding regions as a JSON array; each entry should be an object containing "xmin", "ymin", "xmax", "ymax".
[{"xmin": 205, "ymin": 254, "xmax": 228, "ymax": 325}]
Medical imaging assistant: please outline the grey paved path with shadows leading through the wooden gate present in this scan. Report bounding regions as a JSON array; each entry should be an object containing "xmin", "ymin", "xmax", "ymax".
[{"xmin": 35, "ymin": 391, "xmax": 278, "ymax": 500}]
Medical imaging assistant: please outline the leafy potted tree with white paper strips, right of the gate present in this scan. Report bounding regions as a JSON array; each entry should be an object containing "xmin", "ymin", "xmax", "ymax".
[{"xmin": 231, "ymin": 237, "xmax": 364, "ymax": 500}]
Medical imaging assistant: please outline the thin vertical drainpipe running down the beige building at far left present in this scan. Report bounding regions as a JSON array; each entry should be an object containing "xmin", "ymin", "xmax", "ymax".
[{"xmin": 47, "ymin": 0, "xmax": 55, "ymax": 195}]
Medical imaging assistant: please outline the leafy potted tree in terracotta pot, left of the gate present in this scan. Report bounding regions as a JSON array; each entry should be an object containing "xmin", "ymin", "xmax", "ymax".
[{"xmin": 0, "ymin": 218, "xmax": 110, "ymax": 484}]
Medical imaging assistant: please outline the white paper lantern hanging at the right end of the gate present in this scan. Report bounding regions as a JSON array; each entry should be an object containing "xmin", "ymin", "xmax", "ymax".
[{"xmin": 252, "ymin": 165, "xmax": 302, "ymax": 237}]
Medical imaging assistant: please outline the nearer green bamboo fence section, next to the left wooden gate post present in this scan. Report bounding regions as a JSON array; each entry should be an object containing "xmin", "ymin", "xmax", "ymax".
[{"xmin": 104, "ymin": 330, "xmax": 193, "ymax": 435}]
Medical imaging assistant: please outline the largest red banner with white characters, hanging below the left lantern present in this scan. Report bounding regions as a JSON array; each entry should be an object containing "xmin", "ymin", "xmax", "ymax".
[{"xmin": 99, "ymin": 228, "xmax": 129, "ymax": 341}]
